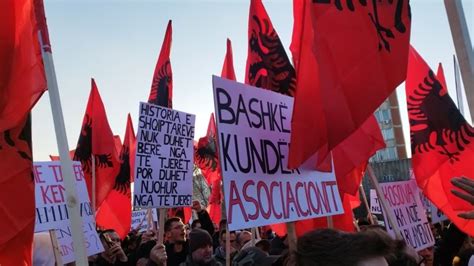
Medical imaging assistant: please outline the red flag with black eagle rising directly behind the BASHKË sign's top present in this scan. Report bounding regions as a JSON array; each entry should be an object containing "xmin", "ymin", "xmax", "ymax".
[{"xmin": 245, "ymin": 0, "xmax": 296, "ymax": 96}]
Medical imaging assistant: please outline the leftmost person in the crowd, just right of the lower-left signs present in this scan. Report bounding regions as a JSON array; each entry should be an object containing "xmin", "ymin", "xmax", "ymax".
[{"xmin": 93, "ymin": 229, "xmax": 129, "ymax": 266}]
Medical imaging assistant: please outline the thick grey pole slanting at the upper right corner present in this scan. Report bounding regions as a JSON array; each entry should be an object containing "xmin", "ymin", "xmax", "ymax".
[{"xmin": 444, "ymin": 0, "xmax": 474, "ymax": 122}]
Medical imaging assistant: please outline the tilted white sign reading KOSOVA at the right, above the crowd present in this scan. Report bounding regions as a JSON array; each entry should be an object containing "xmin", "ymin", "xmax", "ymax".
[{"xmin": 380, "ymin": 180, "xmax": 435, "ymax": 251}]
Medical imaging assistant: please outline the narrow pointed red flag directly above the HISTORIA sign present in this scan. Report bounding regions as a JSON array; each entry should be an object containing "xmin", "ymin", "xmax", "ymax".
[{"xmin": 148, "ymin": 20, "xmax": 173, "ymax": 108}]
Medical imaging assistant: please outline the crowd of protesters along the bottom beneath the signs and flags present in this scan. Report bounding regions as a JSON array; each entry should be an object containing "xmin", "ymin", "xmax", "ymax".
[{"xmin": 34, "ymin": 176, "xmax": 474, "ymax": 266}]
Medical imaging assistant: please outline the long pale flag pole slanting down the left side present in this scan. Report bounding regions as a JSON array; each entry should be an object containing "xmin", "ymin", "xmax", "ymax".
[{"xmin": 38, "ymin": 19, "xmax": 88, "ymax": 265}]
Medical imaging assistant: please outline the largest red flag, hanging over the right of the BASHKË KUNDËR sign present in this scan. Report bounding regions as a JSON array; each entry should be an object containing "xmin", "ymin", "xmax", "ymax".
[{"xmin": 289, "ymin": 0, "xmax": 411, "ymax": 168}]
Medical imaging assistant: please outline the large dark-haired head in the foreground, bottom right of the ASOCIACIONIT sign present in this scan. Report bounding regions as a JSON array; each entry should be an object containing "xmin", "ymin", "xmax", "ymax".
[{"xmin": 295, "ymin": 229, "xmax": 393, "ymax": 266}]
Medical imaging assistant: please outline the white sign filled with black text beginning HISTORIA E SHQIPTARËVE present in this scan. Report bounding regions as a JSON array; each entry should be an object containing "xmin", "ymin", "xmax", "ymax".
[{"xmin": 133, "ymin": 102, "xmax": 195, "ymax": 208}]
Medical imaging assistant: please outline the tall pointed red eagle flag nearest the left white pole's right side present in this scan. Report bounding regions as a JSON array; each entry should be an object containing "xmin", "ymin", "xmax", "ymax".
[{"xmin": 74, "ymin": 79, "xmax": 120, "ymax": 208}]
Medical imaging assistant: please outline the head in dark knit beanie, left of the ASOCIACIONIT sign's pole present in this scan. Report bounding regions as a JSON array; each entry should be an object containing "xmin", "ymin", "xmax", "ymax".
[{"xmin": 189, "ymin": 228, "xmax": 212, "ymax": 265}]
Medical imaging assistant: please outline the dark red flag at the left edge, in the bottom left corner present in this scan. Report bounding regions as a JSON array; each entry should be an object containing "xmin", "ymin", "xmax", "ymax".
[{"xmin": 0, "ymin": 117, "xmax": 35, "ymax": 265}]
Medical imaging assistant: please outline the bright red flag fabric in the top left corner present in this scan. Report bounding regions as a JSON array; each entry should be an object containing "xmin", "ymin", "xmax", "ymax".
[{"xmin": 0, "ymin": 0, "xmax": 46, "ymax": 132}]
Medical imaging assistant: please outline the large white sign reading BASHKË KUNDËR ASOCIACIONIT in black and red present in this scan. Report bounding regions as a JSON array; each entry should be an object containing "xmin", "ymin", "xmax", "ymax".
[{"xmin": 213, "ymin": 76, "xmax": 344, "ymax": 230}]
